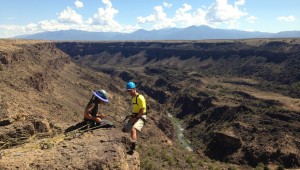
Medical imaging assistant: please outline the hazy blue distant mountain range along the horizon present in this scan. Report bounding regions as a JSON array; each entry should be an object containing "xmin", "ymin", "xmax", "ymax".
[{"xmin": 14, "ymin": 26, "xmax": 300, "ymax": 41}]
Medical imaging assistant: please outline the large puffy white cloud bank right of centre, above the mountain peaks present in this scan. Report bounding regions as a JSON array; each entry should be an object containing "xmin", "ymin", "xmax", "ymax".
[{"xmin": 137, "ymin": 0, "xmax": 247, "ymax": 29}]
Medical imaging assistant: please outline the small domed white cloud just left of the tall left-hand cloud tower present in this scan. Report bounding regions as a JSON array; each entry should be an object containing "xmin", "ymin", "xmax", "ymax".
[{"xmin": 58, "ymin": 7, "xmax": 82, "ymax": 24}]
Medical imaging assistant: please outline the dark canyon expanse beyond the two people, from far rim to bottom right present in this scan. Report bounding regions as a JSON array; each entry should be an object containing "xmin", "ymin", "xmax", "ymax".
[{"xmin": 56, "ymin": 39, "xmax": 300, "ymax": 168}]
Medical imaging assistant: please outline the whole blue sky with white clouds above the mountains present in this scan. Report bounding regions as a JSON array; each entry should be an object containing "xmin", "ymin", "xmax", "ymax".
[{"xmin": 0, "ymin": 0, "xmax": 300, "ymax": 38}]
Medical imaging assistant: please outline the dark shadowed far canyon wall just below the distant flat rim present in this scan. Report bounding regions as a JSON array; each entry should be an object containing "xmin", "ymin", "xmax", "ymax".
[{"xmin": 57, "ymin": 39, "xmax": 300, "ymax": 98}]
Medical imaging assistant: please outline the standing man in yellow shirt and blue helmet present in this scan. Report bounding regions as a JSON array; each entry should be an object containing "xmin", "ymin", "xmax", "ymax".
[{"xmin": 122, "ymin": 82, "xmax": 147, "ymax": 154}]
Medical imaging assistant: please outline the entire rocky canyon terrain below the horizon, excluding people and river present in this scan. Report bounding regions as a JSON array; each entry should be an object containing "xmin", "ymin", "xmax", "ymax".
[{"xmin": 0, "ymin": 39, "xmax": 300, "ymax": 169}]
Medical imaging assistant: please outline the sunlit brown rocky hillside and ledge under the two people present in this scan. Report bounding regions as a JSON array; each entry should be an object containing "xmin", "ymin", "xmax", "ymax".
[{"xmin": 0, "ymin": 40, "xmax": 235, "ymax": 170}]
